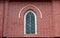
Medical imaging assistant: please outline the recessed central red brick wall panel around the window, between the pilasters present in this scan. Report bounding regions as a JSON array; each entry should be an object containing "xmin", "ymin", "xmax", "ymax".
[{"xmin": 3, "ymin": 2, "xmax": 53, "ymax": 37}]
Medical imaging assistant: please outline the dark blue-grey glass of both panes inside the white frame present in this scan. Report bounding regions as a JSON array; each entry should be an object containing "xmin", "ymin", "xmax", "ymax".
[{"xmin": 26, "ymin": 12, "xmax": 35, "ymax": 34}]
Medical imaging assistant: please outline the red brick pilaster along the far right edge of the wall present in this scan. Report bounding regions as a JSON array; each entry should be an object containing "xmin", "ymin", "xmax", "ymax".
[{"xmin": 52, "ymin": 1, "xmax": 60, "ymax": 36}]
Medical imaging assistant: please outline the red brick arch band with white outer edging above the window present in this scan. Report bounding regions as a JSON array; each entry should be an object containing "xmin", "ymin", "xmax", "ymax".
[{"xmin": 19, "ymin": 4, "xmax": 42, "ymax": 18}]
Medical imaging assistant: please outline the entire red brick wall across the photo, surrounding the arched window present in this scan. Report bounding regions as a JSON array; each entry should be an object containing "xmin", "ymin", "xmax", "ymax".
[{"xmin": 0, "ymin": 1, "xmax": 60, "ymax": 37}]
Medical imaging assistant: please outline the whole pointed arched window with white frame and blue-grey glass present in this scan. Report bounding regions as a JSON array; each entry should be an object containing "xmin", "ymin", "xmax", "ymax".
[{"xmin": 24, "ymin": 10, "xmax": 37, "ymax": 34}]
